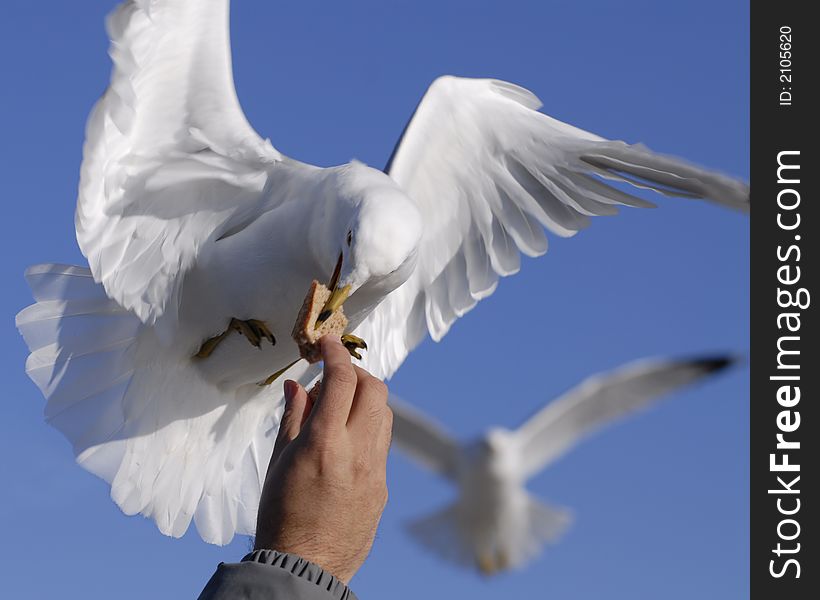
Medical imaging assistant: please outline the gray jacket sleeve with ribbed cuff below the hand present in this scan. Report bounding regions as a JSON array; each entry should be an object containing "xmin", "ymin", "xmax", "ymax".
[{"xmin": 199, "ymin": 550, "xmax": 357, "ymax": 600}]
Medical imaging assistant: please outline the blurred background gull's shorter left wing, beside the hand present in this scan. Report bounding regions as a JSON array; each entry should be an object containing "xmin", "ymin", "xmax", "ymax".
[{"xmin": 390, "ymin": 394, "xmax": 459, "ymax": 478}]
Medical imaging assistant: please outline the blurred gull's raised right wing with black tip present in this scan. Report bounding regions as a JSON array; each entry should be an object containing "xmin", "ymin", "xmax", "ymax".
[{"xmin": 516, "ymin": 356, "xmax": 732, "ymax": 475}]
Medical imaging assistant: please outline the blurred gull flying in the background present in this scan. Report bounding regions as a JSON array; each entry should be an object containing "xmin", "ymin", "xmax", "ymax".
[{"xmin": 390, "ymin": 357, "xmax": 732, "ymax": 575}]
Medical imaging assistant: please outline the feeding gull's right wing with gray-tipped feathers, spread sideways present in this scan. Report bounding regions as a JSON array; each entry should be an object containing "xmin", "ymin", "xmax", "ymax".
[{"xmin": 352, "ymin": 77, "xmax": 749, "ymax": 377}]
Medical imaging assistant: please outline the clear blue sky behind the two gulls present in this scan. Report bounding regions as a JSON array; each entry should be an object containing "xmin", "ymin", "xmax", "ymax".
[{"xmin": 0, "ymin": 0, "xmax": 749, "ymax": 600}]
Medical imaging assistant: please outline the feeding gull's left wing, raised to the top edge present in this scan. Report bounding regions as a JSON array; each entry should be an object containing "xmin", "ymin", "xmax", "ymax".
[{"xmin": 76, "ymin": 0, "xmax": 281, "ymax": 323}]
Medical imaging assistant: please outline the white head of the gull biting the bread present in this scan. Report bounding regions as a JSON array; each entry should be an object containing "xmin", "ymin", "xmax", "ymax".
[{"xmin": 314, "ymin": 162, "xmax": 422, "ymax": 320}]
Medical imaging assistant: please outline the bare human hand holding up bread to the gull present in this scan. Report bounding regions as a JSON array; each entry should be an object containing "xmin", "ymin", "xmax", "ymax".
[{"xmin": 254, "ymin": 336, "xmax": 393, "ymax": 583}]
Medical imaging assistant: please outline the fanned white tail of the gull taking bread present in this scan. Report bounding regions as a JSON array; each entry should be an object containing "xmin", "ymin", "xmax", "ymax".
[{"xmin": 16, "ymin": 264, "xmax": 288, "ymax": 544}]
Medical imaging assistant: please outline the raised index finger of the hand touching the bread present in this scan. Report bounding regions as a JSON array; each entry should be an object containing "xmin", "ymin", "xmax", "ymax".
[{"xmin": 311, "ymin": 335, "xmax": 357, "ymax": 427}]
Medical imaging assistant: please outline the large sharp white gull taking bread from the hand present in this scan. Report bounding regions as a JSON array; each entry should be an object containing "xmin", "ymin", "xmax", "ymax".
[{"xmin": 17, "ymin": 0, "xmax": 749, "ymax": 544}]
